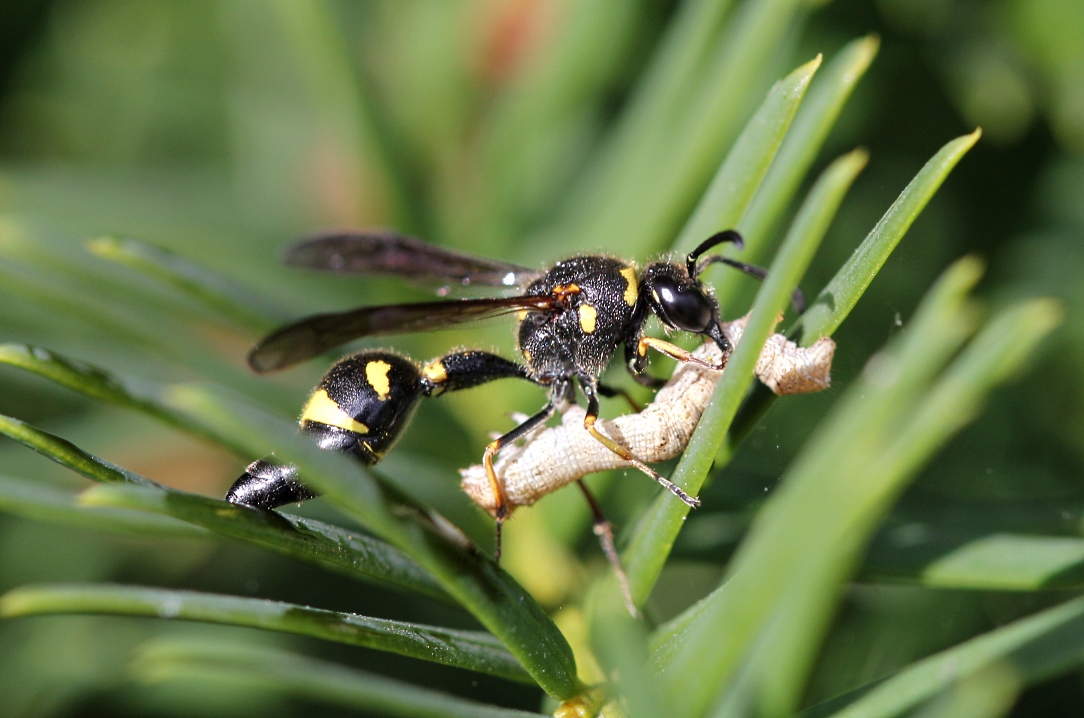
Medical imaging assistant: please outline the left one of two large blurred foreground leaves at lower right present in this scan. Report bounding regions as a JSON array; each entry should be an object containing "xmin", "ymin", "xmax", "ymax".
[{"xmin": 655, "ymin": 262, "xmax": 980, "ymax": 715}]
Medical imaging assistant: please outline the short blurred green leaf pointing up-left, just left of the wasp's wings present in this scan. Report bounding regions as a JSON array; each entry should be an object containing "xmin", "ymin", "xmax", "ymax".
[{"xmin": 87, "ymin": 236, "xmax": 286, "ymax": 332}]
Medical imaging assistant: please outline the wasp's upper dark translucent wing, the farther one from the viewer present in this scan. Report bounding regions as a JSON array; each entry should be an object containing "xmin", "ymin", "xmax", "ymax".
[{"xmin": 285, "ymin": 230, "xmax": 542, "ymax": 287}]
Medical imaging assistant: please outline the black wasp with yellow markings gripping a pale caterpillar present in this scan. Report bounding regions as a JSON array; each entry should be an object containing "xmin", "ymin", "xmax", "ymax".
[{"xmin": 227, "ymin": 230, "xmax": 800, "ymax": 559}]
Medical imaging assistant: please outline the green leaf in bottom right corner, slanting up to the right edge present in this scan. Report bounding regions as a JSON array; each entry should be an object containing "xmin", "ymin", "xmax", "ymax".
[{"xmin": 801, "ymin": 599, "xmax": 1084, "ymax": 718}]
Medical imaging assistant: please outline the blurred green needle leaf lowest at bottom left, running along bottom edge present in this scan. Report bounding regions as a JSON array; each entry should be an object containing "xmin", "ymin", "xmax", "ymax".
[{"xmin": 132, "ymin": 639, "xmax": 542, "ymax": 718}]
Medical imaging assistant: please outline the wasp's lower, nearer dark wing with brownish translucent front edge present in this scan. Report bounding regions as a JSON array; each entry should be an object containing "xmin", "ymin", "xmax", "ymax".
[{"xmin": 248, "ymin": 295, "xmax": 555, "ymax": 372}]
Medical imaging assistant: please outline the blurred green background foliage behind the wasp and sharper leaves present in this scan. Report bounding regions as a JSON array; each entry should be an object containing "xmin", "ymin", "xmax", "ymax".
[{"xmin": 0, "ymin": 0, "xmax": 1084, "ymax": 716}]
